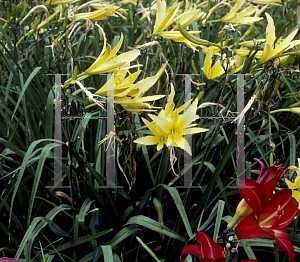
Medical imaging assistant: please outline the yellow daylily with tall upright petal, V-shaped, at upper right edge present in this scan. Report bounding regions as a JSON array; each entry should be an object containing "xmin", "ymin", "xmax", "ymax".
[{"xmin": 258, "ymin": 13, "xmax": 300, "ymax": 64}]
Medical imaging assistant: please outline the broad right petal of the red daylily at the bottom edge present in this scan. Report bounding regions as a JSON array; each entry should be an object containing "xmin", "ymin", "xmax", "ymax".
[{"xmin": 196, "ymin": 231, "xmax": 223, "ymax": 260}]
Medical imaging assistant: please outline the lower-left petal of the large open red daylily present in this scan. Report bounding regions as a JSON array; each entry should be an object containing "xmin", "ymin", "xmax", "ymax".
[{"xmin": 235, "ymin": 214, "xmax": 264, "ymax": 239}]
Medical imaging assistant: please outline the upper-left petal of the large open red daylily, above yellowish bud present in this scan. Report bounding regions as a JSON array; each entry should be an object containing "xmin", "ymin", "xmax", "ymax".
[{"xmin": 239, "ymin": 179, "xmax": 265, "ymax": 216}]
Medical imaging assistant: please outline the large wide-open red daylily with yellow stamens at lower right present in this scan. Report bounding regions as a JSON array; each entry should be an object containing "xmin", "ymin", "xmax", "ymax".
[{"xmin": 235, "ymin": 179, "xmax": 299, "ymax": 262}]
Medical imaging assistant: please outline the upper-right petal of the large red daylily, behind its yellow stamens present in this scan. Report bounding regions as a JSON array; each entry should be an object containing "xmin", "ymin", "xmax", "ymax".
[{"xmin": 259, "ymin": 188, "xmax": 299, "ymax": 229}]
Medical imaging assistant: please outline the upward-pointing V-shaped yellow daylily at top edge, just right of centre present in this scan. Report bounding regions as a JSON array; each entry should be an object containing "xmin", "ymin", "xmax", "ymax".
[{"xmin": 153, "ymin": 0, "xmax": 179, "ymax": 34}]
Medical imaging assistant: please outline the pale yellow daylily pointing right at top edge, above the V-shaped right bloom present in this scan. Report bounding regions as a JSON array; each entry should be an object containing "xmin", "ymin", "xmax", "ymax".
[{"xmin": 219, "ymin": 0, "xmax": 263, "ymax": 24}]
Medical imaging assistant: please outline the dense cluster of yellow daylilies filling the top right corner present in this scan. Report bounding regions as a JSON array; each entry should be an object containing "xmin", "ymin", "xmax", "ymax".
[{"xmin": 151, "ymin": 0, "xmax": 300, "ymax": 79}]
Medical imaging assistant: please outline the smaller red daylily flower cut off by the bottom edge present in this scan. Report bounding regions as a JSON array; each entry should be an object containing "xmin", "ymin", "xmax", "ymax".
[{"xmin": 180, "ymin": 231, "xmax": 225, "ymax": 262}]
